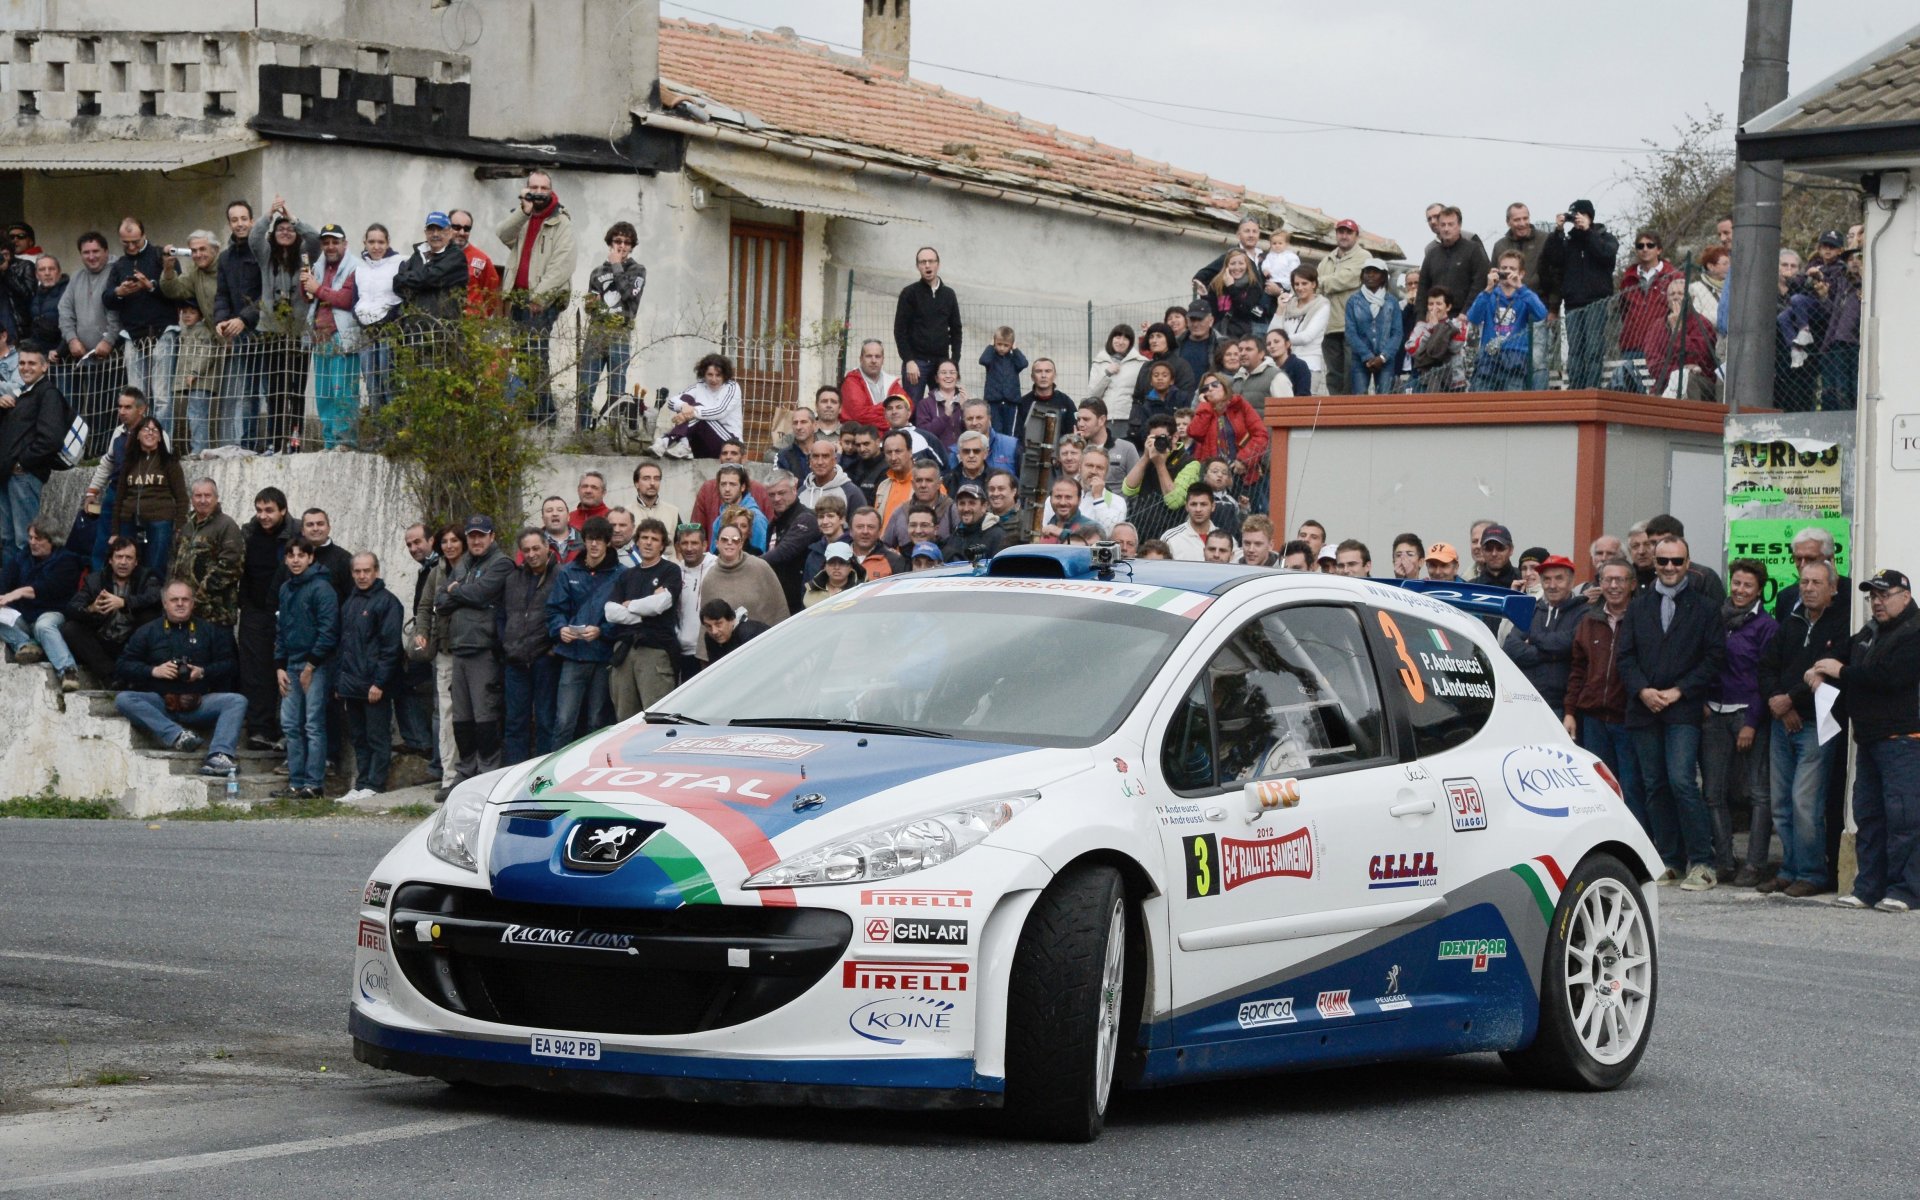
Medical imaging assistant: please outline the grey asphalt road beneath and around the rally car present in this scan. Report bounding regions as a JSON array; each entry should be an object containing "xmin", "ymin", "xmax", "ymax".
[{"xmin": 0, "ymin": 820, "xmax": 1920, "ymax": 1200}]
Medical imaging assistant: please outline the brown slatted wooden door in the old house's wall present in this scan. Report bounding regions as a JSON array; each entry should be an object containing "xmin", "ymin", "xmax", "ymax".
[{"xmin": 726, "ymin": 221, "xmax": 801, "ymax": 457}]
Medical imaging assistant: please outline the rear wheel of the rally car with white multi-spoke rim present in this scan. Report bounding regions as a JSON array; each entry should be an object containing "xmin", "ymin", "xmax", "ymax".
[{"xmin": 1501, "ymin": 854, "xmax": 1659, "ymax": 1092}]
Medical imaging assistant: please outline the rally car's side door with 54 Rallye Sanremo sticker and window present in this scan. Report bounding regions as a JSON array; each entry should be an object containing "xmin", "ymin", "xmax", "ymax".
[{"xmin": 1156, "ymin": 603, "xmax": 1438, "ymax": 1037}]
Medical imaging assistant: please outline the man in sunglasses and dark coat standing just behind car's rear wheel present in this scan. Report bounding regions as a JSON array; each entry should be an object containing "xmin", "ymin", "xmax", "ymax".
[{"xmin": 1620, "ymin": 530, "xmax": 1726, "ymax": 879}]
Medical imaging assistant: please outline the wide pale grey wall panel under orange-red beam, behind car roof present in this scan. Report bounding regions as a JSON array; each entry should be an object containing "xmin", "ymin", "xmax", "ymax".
[{"xmin": 1284, "ymin": 424, "xmax": 1574, "ymax": 574}]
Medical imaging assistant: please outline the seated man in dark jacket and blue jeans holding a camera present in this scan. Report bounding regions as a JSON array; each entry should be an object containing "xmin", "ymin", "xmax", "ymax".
[{"xmin": 113, "ymin": 580, "xmax": 246, "ymax": 776}]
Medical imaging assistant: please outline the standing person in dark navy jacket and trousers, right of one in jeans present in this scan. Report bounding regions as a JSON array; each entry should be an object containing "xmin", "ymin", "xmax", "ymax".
[{"xmin": 334, "ymin": 553, "xmax": 407, "ymax": 801}]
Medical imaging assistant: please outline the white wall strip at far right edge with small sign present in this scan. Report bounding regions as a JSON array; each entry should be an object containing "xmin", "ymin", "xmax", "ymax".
[{"xmin": 1853, "ymin": 172, "xmax": 1920, "ymax": 612}]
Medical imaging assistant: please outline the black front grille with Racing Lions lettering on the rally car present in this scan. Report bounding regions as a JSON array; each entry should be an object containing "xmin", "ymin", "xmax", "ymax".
[{"xmin": 390, "ymin": 883, "xmax": 852, "ymax": 1035}]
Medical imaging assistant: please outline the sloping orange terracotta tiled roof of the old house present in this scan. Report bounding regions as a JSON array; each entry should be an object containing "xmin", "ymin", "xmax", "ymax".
[{"xmin": 660, "ymin": 19, "xmax": 1400, "ymax": 257}]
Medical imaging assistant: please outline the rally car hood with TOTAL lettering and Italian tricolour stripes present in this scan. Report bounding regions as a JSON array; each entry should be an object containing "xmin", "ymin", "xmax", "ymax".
[{"xmin": 488, "ymin": 724, "xmax": 1089, "ymax": 908}]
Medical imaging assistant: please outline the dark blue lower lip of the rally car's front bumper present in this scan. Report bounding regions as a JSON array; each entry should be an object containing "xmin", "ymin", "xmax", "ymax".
[{"xmin": 348, "ymin": 1006, "xmax": 1004, "ymax": 1110}]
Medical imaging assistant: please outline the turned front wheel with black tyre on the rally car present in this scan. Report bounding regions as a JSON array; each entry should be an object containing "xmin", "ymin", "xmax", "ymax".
[{"xmin": 1004, "ymin": 866, "xmax": 1133, "ymax": 1142}]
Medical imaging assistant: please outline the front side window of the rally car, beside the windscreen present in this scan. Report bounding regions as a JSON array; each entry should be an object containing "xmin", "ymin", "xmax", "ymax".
[{"xmin": 1162, "ymin": 607, "xmax": 1386, "ymax": 791}]
